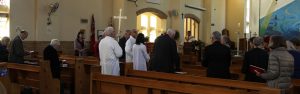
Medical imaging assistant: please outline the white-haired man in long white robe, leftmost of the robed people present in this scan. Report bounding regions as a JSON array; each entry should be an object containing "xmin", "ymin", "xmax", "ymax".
[{"xmin": 99, "ymin": 27, "xmax": 123, "ymax": 76}]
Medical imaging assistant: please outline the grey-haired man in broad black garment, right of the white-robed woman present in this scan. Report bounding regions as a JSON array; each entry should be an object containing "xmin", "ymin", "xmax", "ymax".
[{"xmin": 149, "ymin": 29, "xmax": 180, "ymax": 73}]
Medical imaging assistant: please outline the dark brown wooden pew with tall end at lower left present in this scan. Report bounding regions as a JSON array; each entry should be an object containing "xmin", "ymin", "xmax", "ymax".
[{"xmin": 7, "ymin": 61, "xmax": 60, "ymax": 94}]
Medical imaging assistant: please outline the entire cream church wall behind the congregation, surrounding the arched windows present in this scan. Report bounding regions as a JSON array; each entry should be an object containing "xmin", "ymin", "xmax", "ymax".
[{"xmin": 10, "ymin": 0, "xmax": 205, "ymax": 41}]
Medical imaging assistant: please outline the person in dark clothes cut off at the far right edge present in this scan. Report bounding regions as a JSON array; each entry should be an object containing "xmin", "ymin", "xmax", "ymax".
[{"xmin": 289, "ymin": 38, "xmax": 300, "ymax": 79}]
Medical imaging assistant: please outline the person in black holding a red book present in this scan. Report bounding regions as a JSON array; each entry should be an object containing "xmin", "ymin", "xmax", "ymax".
[{"xmin": 242, "ymin": 37, "xmax": 269, "ymax": 83}]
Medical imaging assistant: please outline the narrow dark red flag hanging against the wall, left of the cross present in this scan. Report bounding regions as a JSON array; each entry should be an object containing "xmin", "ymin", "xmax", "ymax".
[{"xmin": 90, "ymin": 14, "xmax": 97, "ymax": 56}]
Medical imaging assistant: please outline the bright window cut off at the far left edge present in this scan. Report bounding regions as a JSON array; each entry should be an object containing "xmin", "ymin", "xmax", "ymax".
[{"xmin": 0, "ymin": 0, "xmax": 10, "ymax": 39}]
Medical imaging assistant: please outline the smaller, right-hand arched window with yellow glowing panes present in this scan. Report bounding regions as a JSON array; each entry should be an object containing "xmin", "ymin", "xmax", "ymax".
[{"xmin": 184, "ymin": 16, "xmax": 199, "ymax": 41}]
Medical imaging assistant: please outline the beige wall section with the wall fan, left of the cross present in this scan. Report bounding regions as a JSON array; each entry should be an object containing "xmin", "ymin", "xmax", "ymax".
[{"xmin": 10, "ymin": 0, "xmax": 112, "ymax": 41}]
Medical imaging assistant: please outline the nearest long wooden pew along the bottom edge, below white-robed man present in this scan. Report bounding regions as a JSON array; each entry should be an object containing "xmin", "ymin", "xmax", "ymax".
[{"xmin": 90, "ymin": 72, "xmax": 244, "ymax": 94}]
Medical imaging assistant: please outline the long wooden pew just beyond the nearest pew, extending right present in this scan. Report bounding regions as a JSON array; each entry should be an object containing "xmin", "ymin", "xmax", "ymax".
[{"xmin": 127, "ymin": 70, "xmax": 280, "ymax": 94}]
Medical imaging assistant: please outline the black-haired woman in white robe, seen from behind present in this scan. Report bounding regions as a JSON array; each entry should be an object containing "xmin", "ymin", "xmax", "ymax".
[{"xmin": 132, "ymin": 33, "xmax": 150, "ymax": 71}]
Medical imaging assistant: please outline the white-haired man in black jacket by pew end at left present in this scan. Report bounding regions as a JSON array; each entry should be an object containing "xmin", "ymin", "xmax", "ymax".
[{"xmin": 44, "ymin": 39, "xmax": 64, "ymax": 94}]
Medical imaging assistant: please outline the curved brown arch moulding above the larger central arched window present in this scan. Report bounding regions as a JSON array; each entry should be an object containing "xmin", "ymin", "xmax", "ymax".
[{"xmin": 136, "ymin": 8, "xmax": 168, "ymax": 19}]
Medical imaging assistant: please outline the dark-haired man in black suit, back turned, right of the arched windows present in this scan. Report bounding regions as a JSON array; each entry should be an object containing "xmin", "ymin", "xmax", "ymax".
[{"xmin": 202, "ymin": 31, "xmax": 231, "ymax": 79}]
